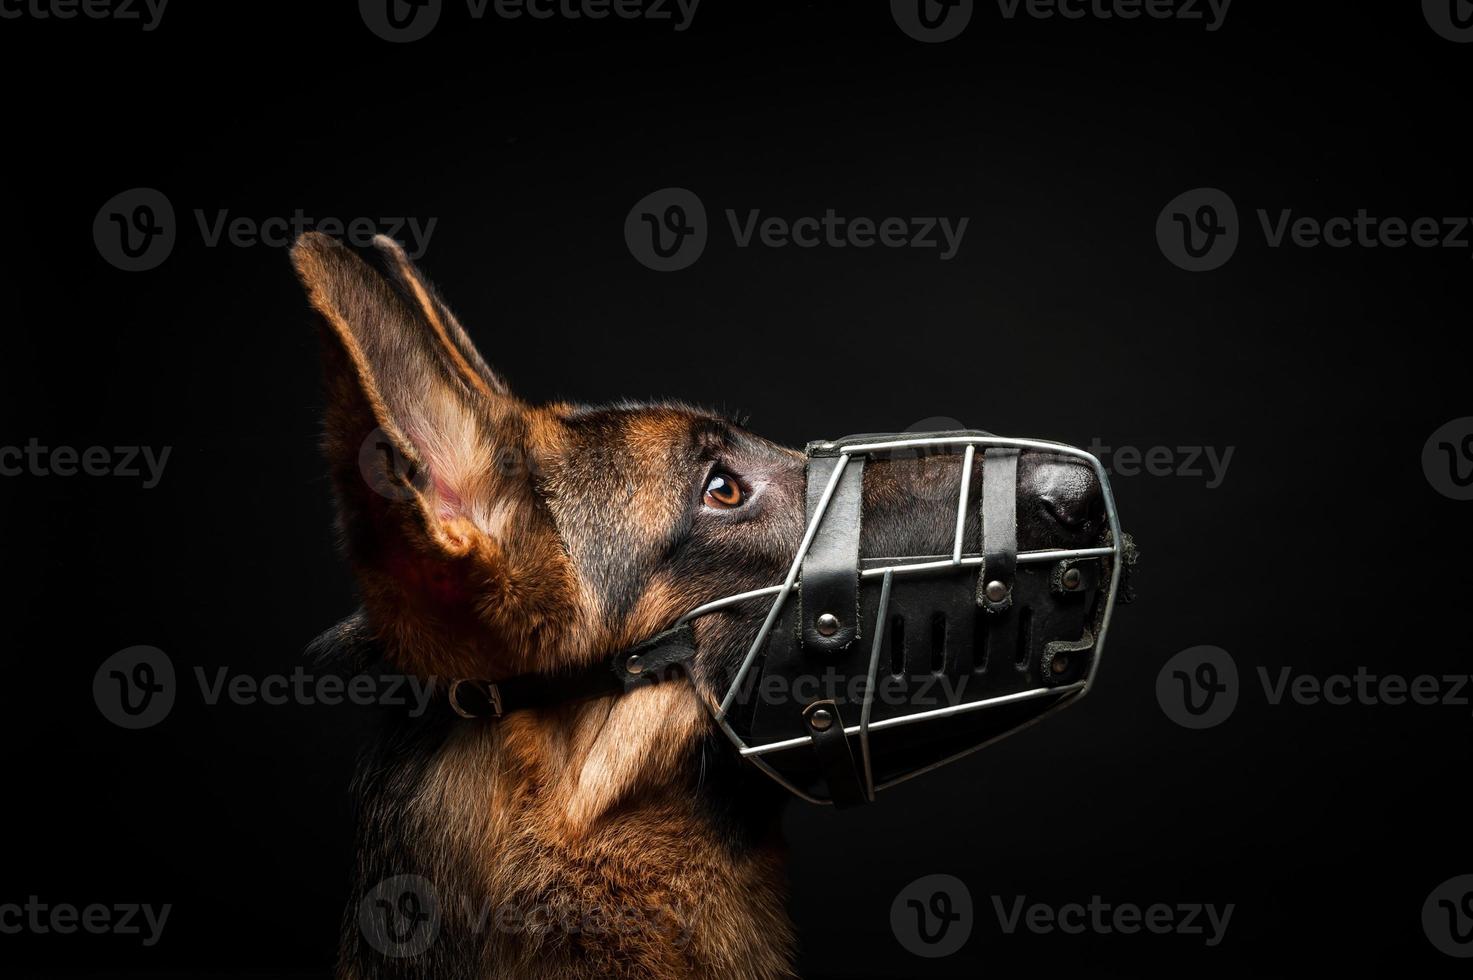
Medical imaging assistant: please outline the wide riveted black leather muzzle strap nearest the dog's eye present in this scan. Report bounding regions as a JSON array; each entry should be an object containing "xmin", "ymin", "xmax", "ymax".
[{"xmin": 798, "ymin": 457, "xmax": 865, "ymax": 653}]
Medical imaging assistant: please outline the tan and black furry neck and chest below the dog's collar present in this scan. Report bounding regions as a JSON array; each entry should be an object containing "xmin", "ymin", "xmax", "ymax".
[{"xmin": 342, "ymin": 684, "xmax": 792, "ymax": 979}]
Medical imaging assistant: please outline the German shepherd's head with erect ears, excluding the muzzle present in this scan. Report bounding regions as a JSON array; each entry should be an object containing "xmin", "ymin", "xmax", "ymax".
[{"xmin": 293, "ymin": 234, "xmax": 1103, "ymax": 795}]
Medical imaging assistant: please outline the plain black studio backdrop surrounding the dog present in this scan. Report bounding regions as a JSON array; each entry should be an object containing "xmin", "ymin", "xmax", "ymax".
[{"xmin": 0, "ymin": 0, "xmax": 1473, "ymax": 977}]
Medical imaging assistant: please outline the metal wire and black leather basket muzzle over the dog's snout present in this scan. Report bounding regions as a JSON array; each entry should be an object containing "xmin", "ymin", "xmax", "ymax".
[{"xmin": 681, "ymin": 430, "xmax": 1133, "ymax": 806}]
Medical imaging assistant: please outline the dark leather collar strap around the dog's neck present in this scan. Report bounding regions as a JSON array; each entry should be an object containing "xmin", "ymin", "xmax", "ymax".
[{"xmin": 446, "ymin": 623, "xmax": 695, "ymax": 718}]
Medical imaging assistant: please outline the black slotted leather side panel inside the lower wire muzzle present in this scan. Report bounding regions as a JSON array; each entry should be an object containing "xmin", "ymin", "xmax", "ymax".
[{"xmin": 732, "ymin": 559, "xmax": 1100, "ymax": 781}]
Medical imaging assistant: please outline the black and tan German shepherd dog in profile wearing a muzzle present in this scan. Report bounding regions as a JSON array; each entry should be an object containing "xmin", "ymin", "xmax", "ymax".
[{"xmin": 292, "ymin": 233, "xmax": 1102, "ymax": 980}]
